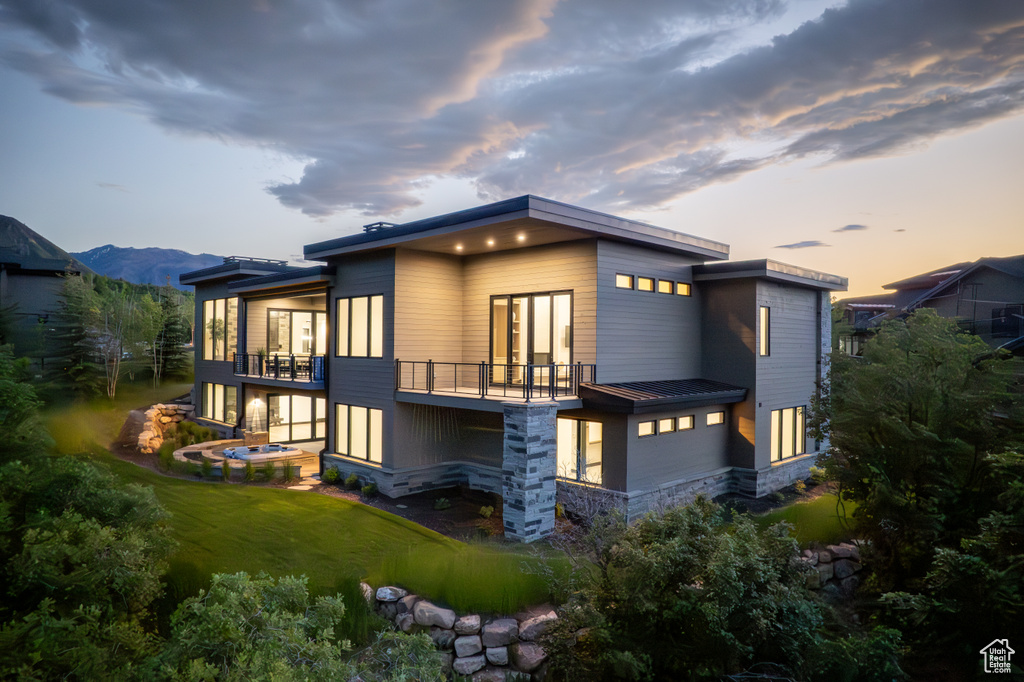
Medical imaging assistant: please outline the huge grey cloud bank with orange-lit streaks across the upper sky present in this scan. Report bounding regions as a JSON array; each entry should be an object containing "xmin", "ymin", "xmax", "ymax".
[{"xmin": 0, "ymin": 0, "xmax": 1024, "ymax": 216}]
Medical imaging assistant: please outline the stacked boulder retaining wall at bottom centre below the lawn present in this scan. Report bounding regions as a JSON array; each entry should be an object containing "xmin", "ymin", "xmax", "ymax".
[{"xmin": 361, "ymin": 583, "xmax": 558, "ymax": 682}]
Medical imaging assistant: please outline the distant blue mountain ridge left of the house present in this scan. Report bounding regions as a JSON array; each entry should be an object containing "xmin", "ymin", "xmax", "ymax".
[{"xmin": 72, "ymin": 244, "xmax": 224, "ymax": 288}]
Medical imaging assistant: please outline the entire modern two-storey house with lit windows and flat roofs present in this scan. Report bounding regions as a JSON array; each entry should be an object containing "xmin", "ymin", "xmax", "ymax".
[{"xmin": 181, "ymin": 196, "xmax": 847, "ymax": 540}]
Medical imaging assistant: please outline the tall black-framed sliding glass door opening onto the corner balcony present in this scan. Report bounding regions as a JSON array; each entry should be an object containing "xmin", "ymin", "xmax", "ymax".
[{"xmin": 490, "ymin": 292, "xmax": 572, "ymax": 384}]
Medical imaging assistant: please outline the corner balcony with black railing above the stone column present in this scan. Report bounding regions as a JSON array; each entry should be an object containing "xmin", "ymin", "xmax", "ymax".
[{"xmin": 394, "ymin": 360, "xmax": 596, "ymax": 400}]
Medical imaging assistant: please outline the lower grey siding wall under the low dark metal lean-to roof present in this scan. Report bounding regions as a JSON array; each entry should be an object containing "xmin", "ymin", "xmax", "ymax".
[{"xmin": 627, "ymin": 406, "xmax": 732, "ymax": 491}]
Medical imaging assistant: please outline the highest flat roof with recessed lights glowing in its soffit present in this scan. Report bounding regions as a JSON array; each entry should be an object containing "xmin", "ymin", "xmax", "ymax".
[{"xmin": 304, "ymin": 195, "xmax": 729, "ymax": 260}]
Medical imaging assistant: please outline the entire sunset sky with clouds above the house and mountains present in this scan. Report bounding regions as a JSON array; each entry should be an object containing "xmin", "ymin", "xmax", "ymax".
[{"xmin": 0, "ymin": 0, "xmax": 1024, "ymax": 295}]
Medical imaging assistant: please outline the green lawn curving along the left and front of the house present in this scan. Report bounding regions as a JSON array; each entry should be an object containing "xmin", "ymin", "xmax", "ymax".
[{"xmin": 47, "ymin": 387, "xmax": 548, "ymax": 612}]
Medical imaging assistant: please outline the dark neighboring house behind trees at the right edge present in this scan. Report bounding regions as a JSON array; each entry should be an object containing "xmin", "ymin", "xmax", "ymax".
[{"xmin": 839, "ymin": 255, "xmax": 1024, "ymax": 355}]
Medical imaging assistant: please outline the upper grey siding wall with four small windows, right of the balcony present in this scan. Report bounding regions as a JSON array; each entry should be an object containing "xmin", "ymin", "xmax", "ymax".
[{"xmin": 597, "ymin": 241, "xmax": 701, "ymax": 383}]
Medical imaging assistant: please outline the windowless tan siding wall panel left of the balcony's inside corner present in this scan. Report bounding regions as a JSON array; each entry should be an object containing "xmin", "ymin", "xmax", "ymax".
[{"xmin": 394, "ymin": 250, "xmax": 463, "ymax": 363}]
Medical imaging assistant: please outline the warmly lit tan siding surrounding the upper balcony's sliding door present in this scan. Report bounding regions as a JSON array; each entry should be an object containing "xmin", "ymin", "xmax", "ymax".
[{"xmin": 462, "ymin": 240, "xmax": 600, "ymax": 364}]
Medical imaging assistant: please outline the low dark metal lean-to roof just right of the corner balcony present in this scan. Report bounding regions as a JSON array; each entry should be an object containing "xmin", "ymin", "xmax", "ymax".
[{"xmin": 580, "ymin": 379, "xmax": 746, "ymax": 415}]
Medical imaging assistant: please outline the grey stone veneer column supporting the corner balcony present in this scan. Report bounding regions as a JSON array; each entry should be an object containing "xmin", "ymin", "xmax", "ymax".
[{"xmin": 502, "ymin": 402, "xmax": 558, "ymax": 543}]
